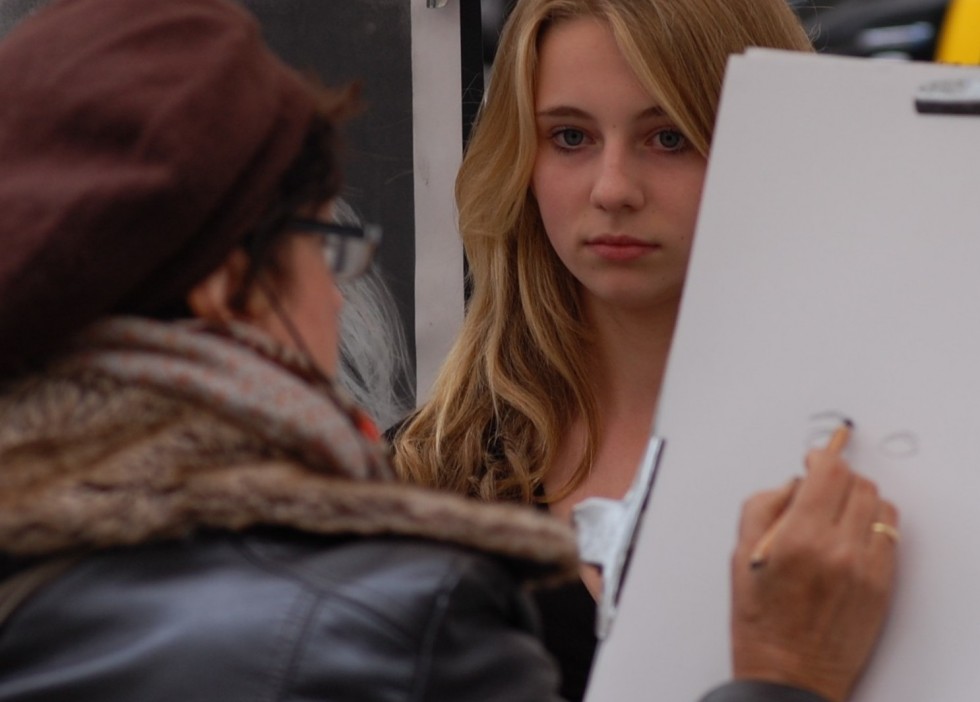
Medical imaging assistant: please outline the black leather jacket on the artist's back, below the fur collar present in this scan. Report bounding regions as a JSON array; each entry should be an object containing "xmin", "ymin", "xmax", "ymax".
[{"xmin": 0, "ymin": 533, "xmax": 558, "ymax": 702}]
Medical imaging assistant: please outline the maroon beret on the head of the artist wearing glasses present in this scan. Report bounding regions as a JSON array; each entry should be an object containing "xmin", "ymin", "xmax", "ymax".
[{"xmin": 0, "ymin": 0, "xmax": 316, "ymax": 372}]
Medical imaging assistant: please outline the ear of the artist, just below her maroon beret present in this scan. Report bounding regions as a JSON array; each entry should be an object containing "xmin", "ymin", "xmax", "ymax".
[{"xmin": 187, "ymin": 249, "xmax": 268, "ymax": 323}]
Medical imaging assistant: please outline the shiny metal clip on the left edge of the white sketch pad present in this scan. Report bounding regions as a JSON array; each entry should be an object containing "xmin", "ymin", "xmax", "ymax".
[{"xmin": 572, "ymin": 436, "xmax": 664, "ymax": 639}]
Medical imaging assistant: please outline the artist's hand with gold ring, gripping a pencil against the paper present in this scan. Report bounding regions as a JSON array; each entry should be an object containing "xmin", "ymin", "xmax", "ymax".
[{"xmin": 732, "ymin": 451, "xmax": 898, "ymax": 702}]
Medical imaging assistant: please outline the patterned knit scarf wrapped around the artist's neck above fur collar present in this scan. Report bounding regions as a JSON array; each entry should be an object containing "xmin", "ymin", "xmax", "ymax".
[{"xmin": 61, "ymin": 317, "xmax": 392, "ymax": 480}]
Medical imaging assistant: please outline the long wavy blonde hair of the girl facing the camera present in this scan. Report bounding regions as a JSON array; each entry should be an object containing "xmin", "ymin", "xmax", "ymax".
[{"xmin": 394, "ymin": 0, "xmax": 811, "ymax": 502}]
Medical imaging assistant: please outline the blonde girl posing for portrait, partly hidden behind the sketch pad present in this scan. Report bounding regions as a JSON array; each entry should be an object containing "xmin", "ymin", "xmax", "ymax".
[{"xmin": 394, "ymin": 0, "xmax": 891, "ymax": 699}]
